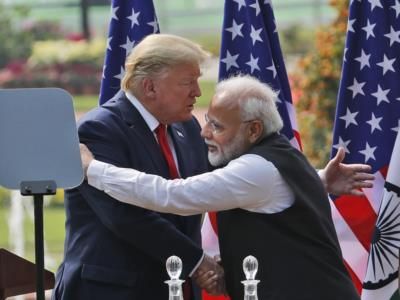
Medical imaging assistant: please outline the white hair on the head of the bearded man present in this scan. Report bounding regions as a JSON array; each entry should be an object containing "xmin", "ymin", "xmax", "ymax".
[{"xmin": 215, "ymin": 75, "xmax": 283, "ymax": 137}]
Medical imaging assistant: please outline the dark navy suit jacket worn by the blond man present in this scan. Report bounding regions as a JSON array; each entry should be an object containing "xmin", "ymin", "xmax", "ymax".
[{"xmin": 53, "ymin": 95, "xmax": 208, "ymax": 300}]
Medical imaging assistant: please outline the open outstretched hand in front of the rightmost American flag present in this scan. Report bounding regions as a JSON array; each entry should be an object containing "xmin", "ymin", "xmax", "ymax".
[{"xmin": 318, "ymin": 148, "xmax": 374, "ymax": 196}]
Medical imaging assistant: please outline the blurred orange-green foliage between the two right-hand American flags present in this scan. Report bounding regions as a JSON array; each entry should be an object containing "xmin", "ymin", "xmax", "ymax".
[{"xmin": 293, "ymin": 0, "xmax": 349, "ymax": 167}]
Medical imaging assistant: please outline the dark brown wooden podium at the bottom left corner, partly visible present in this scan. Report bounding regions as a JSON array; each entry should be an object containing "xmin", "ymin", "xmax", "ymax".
[{"xmin": 0, "ymin": 249, "xmax": 54, "ymax": 300}]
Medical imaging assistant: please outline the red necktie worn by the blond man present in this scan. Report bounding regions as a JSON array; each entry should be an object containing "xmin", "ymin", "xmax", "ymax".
[{"xmin": 155, "ymin": 123, "xmax": 192, "ymax": 300}]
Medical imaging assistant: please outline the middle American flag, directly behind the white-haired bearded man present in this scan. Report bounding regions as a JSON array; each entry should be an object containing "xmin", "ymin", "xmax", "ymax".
[{"xmin": 202, "ymin": 0, "xmax": 300, "ymax": 299}]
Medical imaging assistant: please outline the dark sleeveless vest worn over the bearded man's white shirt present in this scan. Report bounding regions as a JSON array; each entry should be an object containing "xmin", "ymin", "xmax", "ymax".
[{"xmin": 217, "ymin": 134, "xmax": 360, "ymax": 300}]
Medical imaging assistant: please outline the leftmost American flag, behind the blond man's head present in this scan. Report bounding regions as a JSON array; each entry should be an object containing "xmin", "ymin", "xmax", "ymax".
[{"xmin": 99, "ymin": 0, "xmax": 159, "ymax": 104}]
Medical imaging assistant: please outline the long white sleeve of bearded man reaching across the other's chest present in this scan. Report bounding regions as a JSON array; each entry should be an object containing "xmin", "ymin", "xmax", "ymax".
[{"xmin": 87, "ymin": 154, "xmax": 280, "ymax": 215}]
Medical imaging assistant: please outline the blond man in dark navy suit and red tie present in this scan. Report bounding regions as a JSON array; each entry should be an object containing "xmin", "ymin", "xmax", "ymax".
[{"xmin": 53, "ymin": 35, "xmax": 222, "ymax": 300}]
